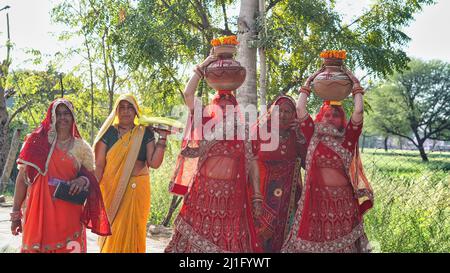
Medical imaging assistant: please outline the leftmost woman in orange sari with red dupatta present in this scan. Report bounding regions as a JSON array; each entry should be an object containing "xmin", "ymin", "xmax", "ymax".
[{"xmin": 11, "ymin": 99, "xmax": 111, "ymax": 253}]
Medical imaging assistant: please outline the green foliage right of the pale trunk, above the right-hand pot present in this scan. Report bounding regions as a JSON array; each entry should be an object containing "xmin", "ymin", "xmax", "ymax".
[{"xmin": 267, "ymin": 0, "xmax": 434, "ymax": 101}]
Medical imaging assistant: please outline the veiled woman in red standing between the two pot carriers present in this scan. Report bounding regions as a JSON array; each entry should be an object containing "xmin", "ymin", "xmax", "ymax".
[{"xmin": 251, "ymin": 96, "xmax": 306, "ymax": 253}]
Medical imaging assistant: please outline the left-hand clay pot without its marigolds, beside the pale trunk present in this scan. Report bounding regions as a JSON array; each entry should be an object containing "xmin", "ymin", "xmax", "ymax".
[{"xmin": 205, "ymin": 45, "xmax": 246, "ymax": 90}]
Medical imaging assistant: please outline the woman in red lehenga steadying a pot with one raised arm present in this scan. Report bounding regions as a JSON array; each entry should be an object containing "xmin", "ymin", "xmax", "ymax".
[{"xmin": 165, "ymin": 56, "xmax": 262, "ymax": 253}]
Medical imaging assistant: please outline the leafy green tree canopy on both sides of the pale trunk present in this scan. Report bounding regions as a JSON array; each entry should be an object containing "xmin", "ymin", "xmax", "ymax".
[{"xmin": 39, "ymin": 0, "xmax": 440, "ymax": 135}]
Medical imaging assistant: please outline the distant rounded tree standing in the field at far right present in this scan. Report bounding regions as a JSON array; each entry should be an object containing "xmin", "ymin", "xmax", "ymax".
[{"xmin": 367, "ymin": 60, "xmax": 450, "ymax": 153}]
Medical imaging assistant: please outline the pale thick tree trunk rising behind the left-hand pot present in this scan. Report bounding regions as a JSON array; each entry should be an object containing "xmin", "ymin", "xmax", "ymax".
[{"xmin": 237, "ymin": 0, "xmax": 258, "ymax": 107}]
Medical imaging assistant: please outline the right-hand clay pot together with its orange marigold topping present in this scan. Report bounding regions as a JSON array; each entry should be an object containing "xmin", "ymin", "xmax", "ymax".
[{"xmin": 311, "ymin": 50, "xmax": 353, "ymax": 101}]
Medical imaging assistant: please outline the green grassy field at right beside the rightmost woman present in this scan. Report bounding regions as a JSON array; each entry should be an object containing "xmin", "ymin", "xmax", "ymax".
[{"xmin": 362, "ymin": 149, "xmax": 450, "ymax": 252}]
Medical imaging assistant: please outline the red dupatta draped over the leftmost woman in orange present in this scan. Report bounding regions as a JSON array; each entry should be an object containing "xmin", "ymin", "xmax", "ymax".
[{"xmin": 17, "ymin": 98, "xmax": 111, "ymax": 236}]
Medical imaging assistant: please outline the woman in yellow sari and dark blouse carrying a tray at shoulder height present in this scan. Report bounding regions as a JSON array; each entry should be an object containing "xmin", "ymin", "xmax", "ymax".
[{"xmin": 94, "ymin": 94, "xmax": 167, "ymax": 253}]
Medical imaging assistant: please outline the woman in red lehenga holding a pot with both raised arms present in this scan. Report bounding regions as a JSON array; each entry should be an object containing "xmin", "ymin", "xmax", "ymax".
[{"xmin": 282, "ymin": 69, "xmax": 373, "ymax": 252}]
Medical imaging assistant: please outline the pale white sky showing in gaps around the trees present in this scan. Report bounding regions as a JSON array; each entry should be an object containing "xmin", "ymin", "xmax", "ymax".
[{"xmin": 0, "ymin": 0, "xmax": 450, "ymax": 72}]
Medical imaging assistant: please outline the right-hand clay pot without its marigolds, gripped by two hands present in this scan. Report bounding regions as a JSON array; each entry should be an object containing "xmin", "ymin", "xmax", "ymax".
[{"xmin": 311, "ymin": 58, "xmax": 353, "ymax": 101}]
